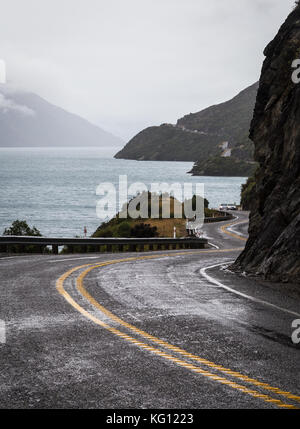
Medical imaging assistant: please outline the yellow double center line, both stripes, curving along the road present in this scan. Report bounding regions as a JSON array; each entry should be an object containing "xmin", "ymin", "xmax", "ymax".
[{"xmin": 57, "ymin": 249, "xmax": 300, "ymax": 409}]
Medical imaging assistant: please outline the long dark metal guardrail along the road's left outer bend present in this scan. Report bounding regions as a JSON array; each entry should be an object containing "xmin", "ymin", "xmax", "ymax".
[{"xmin": 0, "ymin": 235, "xmax": 208, "ymax": 254}]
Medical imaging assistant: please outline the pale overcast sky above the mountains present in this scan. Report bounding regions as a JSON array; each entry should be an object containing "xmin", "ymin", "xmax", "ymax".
[{"xmin": 0, "ymin": 0, "xmax": 294, "ymax": 140}]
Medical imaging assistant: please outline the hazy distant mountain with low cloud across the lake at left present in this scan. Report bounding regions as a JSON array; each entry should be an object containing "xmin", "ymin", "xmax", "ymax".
[{"xmin": 0, "ymin": 84, "xmax": 122, "ymax": 150}]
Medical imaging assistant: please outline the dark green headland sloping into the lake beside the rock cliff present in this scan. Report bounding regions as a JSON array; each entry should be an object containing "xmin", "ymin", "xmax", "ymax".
[{"xmin": 115, "ymin": 83, "xmax": 258, "ymax": 174}]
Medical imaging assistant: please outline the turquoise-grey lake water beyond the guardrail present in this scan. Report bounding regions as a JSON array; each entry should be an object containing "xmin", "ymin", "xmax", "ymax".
[{"xmin": 0, "ymin": 148, "xmax": 247, "ymax": 237}]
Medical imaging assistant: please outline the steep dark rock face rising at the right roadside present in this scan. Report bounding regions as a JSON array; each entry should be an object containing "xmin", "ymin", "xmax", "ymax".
[{"xmin": 233, "ymin": 6, "xmax": 300, "ymax": 283}]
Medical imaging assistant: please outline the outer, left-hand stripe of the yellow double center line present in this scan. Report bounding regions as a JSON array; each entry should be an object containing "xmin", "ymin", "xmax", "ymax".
[{"xmin": 56, "ymin": 267, "xmax": 297, "ymax": 409}]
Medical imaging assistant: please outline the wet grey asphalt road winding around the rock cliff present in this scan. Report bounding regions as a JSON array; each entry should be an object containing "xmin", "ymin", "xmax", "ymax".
[{"xmin": 0, "ymin": 213, "xmax": 300, "ymax": 409}]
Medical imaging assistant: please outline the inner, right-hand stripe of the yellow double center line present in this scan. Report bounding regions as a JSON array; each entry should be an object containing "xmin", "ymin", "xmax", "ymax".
[{"xmin": 77, "ymin": 257, "xmax": 300, "ymax": 402}]
